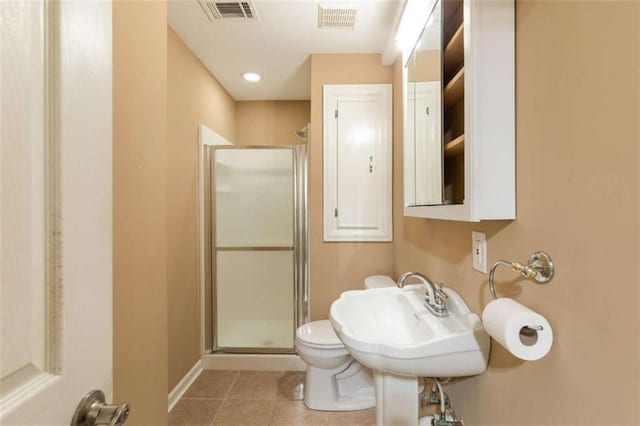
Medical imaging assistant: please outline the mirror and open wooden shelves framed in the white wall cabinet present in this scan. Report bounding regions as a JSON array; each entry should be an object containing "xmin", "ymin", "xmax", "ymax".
[{"xmin": 404, "ymin": 0, "xmax": 465, "ymax": 206}]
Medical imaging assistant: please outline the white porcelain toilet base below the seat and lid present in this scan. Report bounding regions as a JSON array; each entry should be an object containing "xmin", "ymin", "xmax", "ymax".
[{"xmin": 304, "ymin": 360, "xmax": 376, "ymax": 411}]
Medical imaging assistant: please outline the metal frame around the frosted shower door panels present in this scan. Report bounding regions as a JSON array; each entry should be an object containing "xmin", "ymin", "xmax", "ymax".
[{"xmin": 204, "ymin": 144, "xmax": 309, "ymax": 354}]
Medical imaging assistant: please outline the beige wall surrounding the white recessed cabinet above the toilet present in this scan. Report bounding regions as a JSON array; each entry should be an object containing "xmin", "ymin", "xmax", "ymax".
[{"xmin": 309, "ymin": 54, "xmax": 393, "ymax": 320}]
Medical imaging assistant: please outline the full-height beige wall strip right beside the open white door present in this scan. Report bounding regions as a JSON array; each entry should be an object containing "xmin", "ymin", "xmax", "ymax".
[{"xmin": 112, "ymin": 1, "xmax": 167, "ymax": 425}]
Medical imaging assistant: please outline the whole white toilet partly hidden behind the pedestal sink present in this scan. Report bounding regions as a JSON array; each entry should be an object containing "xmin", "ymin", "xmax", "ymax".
[{"xmin": 296, "ymin": 275, "xmax": 396, "ymax": 411}]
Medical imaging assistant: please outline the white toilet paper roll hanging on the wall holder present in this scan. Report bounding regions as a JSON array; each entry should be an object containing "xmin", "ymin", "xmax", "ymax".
[{"xmin": 482, "ymin": 298, "xmax": 553, "ymax": 361}]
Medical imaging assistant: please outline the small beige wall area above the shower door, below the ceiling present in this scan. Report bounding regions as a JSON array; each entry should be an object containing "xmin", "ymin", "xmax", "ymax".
[{"xmin": 234, "ymin": 101, "xmax": 311, "ymax": 145}]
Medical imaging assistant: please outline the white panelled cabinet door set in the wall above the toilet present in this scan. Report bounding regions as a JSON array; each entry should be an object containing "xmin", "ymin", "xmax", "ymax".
[{"xmin": 323, "ymin": 84, "xmax": 392, "ymax": 241}]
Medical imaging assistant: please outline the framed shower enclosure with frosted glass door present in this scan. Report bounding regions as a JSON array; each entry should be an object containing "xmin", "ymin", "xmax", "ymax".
[{"xmin": 204, "ymin": 144, "xmax": 309, "ymax": 353}]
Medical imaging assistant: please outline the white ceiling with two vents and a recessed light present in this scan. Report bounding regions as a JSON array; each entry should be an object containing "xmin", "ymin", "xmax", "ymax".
[{"xmin": 168, "ymin": 0, "xmax": 403, "ymax": 100}]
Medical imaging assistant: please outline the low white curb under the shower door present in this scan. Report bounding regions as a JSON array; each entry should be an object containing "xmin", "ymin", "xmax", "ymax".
[{"xmin": 202, "ymin": 354, "xmax": 307, "ymax": 371}]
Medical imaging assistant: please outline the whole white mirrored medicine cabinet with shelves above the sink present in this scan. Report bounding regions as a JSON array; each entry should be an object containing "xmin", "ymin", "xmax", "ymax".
[{"xmin": 403, "ymin": 0, "xmax": 515, "ymax": 221}]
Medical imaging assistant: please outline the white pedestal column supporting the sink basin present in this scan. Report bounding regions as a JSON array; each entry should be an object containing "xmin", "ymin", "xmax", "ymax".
[{"xmin": 373, "ymin": 370, "xmax": 418, "ymax": 426}]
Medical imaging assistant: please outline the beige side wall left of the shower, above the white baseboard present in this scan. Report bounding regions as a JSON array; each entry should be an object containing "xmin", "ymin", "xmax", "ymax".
[{"xmin": 165, "ymin": 27, "xmax": 235, "ymax": 390}]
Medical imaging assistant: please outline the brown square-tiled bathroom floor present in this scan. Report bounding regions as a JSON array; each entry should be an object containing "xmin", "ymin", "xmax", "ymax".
[{"xmin": 169, "ymin": 370, "xmax": 375, "ymax": 426}]
